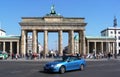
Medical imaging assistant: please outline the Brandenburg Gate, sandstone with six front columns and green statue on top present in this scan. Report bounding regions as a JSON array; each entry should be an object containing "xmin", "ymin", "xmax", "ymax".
[{"xmin": 19, "ymin": 7, "xmax": 86, "ymax": 57}]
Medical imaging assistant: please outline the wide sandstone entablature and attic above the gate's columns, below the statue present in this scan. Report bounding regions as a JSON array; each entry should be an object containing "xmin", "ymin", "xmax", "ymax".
[{"xmin": 20, "ymin": 16, "xmax": 86, "ymax": 31}]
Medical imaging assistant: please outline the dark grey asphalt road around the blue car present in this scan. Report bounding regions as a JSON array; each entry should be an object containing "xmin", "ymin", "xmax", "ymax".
[{"xmin": 0, "ymin": 60, "xmax": 120, "ymax": 77}]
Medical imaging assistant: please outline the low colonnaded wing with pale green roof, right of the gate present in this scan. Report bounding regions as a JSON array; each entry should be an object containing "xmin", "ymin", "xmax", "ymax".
[{"xmin": 86, "ymin": 36, "xmax": 115, "ymax": 54}]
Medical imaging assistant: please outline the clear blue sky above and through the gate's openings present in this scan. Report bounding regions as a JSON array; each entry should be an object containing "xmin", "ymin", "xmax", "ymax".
[{"xmin": 0, "ymin": 0, "xmax": 120, "ymax": 48}]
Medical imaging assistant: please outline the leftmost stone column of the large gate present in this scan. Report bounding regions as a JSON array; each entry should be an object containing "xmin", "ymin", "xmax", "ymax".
[{"xmin": 21, "ymin": 30, "xmax": 26, "ymax": 56}]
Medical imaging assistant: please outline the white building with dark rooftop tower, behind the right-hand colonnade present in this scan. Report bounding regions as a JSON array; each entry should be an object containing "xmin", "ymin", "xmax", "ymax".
[{"xmin": 101, "ymin": 16, "xmax": 120, "ymax": 54}]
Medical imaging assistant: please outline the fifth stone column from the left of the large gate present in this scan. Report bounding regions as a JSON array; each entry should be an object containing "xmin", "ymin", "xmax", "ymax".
[{"xmin": 68, "ymin": 30, "xmax": 74, "ymax": 54}]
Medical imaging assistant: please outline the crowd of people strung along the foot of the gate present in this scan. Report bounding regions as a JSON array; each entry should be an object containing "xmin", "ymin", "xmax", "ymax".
[{"xmin": 3, "ymin": 52, "xmax": 118, "ymax": 60}]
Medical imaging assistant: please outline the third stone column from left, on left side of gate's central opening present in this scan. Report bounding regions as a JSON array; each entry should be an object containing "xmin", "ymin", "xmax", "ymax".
[{"xmin": 43, "ymin": 30, "xmax": 48, "ymax": 58}]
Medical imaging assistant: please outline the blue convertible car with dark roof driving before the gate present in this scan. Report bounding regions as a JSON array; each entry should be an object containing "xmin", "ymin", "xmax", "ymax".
[{"xmin": 44, "ymin": 56, "xmax": 86, "ymax": 74}]
